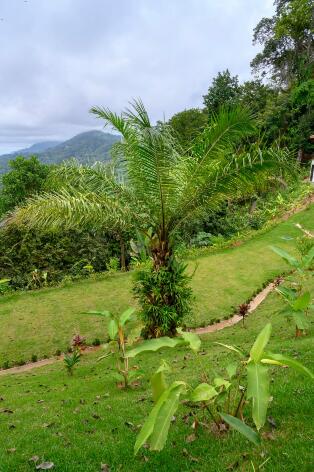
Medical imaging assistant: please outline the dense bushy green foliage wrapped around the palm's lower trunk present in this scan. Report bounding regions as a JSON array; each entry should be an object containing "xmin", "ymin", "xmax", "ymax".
[{"xmin": 133, "ymin": 258, "xmax": 192, "ymax": 338}]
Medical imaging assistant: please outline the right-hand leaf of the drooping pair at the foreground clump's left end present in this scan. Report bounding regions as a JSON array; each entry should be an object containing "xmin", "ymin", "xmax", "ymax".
[{"xmin": 149, "ymin": 382, "xmax": 185, "ymax": 451}]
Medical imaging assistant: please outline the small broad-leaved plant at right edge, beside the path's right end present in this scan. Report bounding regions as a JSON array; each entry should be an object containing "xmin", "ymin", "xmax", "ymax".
[{"xmin": 276, "ymin": 287, "xmax": 314, "ymax": 337}]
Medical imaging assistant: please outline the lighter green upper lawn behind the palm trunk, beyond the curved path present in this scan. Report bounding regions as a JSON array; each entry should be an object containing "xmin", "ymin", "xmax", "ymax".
[{"xmin": 0, "ymin": 205, "xmax": 314, "ymax": 366}]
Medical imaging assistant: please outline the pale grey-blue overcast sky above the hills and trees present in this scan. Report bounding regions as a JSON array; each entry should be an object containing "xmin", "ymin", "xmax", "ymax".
[{"xmin": 0, "ymin": 0, "xmax": 273, "ymax": 154}]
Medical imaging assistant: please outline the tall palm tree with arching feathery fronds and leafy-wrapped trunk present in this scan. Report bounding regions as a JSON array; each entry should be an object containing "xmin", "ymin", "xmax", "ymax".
[{"xmin": 9, "ymin": 101, "xmax": 289, "ymax": 335}]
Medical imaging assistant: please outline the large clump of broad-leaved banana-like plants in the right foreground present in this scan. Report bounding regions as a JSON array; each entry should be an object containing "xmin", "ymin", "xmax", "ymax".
[{"xmin": 134, "ymin": 323, "xmax": 314, "ymax": 454}]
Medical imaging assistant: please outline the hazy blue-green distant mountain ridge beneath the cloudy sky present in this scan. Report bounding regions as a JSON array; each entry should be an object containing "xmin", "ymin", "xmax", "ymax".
[{"xmin": 0, "ymin": 130, "xmax": 120, "ymax": 174}]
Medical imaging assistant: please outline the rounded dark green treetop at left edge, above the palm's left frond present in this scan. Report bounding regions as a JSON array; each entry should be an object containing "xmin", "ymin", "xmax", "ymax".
[{"xmin": 0, "ymin": 156, "xmax": 50, "ymax": 213}]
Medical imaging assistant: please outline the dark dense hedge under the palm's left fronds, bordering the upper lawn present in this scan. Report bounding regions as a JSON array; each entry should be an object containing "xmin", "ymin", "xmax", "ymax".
[{"xmin": 0, "ymin": 225, "xmax": 119, "ymax": 291}]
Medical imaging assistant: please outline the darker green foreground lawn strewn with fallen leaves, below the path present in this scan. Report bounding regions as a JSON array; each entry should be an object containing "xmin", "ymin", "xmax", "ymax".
[{"xmin": 0, "ymin": 274, "xmax": 314, "ymax": 472}]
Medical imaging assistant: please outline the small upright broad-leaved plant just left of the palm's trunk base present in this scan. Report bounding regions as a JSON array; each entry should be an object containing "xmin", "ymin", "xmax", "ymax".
[{"xmin": 88, "ymin": 308, "xmax": 137, "ymax": 388}]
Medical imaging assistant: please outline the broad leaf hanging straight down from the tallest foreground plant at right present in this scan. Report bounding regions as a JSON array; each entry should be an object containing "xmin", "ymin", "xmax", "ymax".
[{"xmin": 247, "ymin": 362, "xmax": 269, "ymax": 431}]
